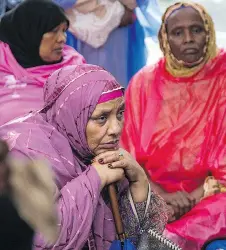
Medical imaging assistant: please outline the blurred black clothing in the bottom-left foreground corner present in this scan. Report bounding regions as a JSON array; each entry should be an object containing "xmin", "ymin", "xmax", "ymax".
[{"xmin": 0, "ymin": 195, "xmax": 34, "ymax": 250}]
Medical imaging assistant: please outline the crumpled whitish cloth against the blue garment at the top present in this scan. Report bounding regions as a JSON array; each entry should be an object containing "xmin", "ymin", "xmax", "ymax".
[{"xmin": 67, "ymin": 0, "xmax": 125, "ymax": 48}]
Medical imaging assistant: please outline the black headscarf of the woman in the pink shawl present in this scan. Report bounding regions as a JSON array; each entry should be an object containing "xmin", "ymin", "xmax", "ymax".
[{"xmin": 0, "ymin": 0, "xmax": 69, "ymax": 68}]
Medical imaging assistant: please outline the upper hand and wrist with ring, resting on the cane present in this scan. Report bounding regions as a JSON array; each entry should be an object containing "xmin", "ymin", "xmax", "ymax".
[{"xmin": 94, "ymin": 149, "xmax": 149, "ymax": 202}]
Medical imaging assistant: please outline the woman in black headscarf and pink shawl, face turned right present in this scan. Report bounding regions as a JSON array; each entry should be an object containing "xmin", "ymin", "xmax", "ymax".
[{"xmin": 0, "ymin": 0, "xmax": 84, "ymax": 125}]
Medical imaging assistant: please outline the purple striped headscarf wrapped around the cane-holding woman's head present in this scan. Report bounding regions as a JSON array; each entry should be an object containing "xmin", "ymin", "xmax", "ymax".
[{"xmin": 41, "ymin": 65, "xmax": 123, "ymax": 180}]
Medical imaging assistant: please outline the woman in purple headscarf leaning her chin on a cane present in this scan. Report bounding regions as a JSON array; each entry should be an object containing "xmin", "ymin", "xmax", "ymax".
[{"xmin": 0, "ymin": 64, "xmax": 166, "ymax": 250}]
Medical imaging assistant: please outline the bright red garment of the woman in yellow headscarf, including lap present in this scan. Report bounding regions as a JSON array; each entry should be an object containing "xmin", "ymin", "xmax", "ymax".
[{"xmin": 121, "ymin": 50, "xmax": 226, "ymax": 250}]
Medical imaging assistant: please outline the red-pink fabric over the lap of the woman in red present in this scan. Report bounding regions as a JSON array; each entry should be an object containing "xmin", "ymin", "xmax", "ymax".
[{"xmin": 167, "ymin": 193, "xmax": 226, "ymax": 247}]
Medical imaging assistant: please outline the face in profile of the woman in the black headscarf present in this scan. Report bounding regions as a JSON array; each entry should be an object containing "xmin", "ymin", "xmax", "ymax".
[{"xmin": 39, "ymin": 22, "xmax": 68, "ymax": 62}]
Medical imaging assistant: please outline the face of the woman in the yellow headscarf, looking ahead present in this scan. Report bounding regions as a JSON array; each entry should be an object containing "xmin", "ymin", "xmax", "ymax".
[{"xmin": 166, "ymin": 7, "xmax": 206, "ymax": 66}]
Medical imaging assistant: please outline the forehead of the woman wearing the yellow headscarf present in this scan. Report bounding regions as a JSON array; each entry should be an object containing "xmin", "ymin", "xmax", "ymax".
[{"xmin": 165, "ymin": 5, "xmax": 204, "ymax": 31}]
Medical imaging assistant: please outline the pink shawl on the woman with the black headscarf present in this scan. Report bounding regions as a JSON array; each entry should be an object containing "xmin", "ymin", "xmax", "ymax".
[{"xmin": 0, "ymin": 42, "xmax": 85, "ymax": 125}]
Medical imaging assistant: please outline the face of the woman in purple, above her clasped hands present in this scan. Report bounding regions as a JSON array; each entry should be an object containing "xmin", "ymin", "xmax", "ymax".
[{"xmin": 86, "ymin": 97, "xmax": 125, "ymax": 155}]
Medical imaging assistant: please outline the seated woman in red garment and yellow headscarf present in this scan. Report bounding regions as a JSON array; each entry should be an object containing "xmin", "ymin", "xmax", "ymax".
[{"xmin": 122, "ymin": 3, "xmax": 226, "ymax": 250}]
